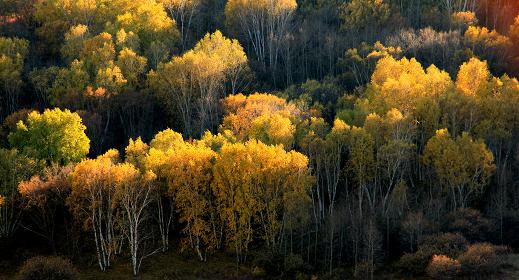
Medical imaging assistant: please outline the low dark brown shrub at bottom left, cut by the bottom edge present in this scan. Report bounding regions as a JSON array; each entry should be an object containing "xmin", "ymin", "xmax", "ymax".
[{"xmin": 17, "ymin": 256, "xmax": 77, "ymax": 280}]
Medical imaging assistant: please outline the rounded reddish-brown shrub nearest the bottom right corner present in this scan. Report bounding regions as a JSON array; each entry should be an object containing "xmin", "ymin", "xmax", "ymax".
[{"xmin": 459, "ymin": 243, "xmax": 508, "ymax": 275}]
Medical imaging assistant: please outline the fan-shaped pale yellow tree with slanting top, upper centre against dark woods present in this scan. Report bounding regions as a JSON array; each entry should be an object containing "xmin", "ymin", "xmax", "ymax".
[{"xmin": 148, "ymin": 31, "xmax": 247, "ymax": 136}]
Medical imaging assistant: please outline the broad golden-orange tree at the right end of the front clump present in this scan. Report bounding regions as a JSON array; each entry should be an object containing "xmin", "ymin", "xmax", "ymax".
[{"xmin": 211, "ymin": 140, "xmax": 312, "ymax": 262}]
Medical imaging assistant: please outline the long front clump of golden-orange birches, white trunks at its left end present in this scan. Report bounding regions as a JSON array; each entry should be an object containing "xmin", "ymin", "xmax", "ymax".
[{"xmin": 63, "ymin": 124, "xmax": 313, "ymax": 274}]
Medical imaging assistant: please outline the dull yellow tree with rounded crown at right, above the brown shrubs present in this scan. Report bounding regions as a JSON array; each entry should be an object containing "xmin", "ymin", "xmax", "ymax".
[{"xmin": 422, "ymin": 129, "xmax": 495, "ymax": 209}]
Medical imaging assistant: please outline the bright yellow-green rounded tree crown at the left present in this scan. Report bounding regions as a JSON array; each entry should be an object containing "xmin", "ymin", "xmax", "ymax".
[{"xmin": 9, "ymin": 109, "xmax": 90, "ymax": 164}]
